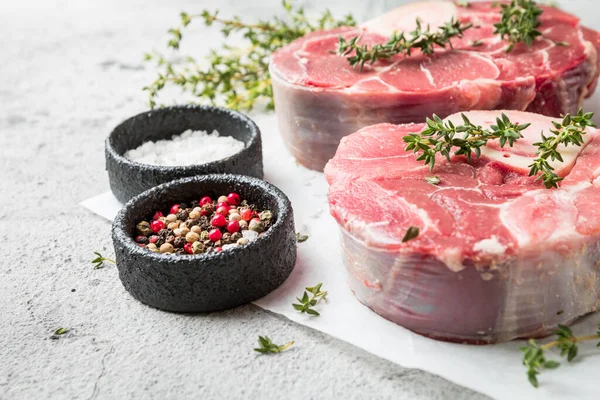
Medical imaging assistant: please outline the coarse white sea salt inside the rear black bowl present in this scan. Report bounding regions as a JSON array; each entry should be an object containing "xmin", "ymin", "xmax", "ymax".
[{"xmin": 125, "ymin": 129, "xmax": 244, "ymax": 166}]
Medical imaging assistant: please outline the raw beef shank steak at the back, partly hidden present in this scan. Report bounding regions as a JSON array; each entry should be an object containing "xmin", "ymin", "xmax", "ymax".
[{"xmin": 270, "ymin": 1, "xmax": 600, "ymax": 170}]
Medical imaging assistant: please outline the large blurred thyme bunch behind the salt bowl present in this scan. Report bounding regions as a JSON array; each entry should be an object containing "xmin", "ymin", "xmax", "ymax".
[{"xmin": 144, "ymin": 0, "xmax": 356, "ymax": 110}]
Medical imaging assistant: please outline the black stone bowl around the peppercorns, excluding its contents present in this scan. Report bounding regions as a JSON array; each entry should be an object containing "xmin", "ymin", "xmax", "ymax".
[{"xmin": 112, "ymin": 175, "xmax": 296, "ymax": 312}]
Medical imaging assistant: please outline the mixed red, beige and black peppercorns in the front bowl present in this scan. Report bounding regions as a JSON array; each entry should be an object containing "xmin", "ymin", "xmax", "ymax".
[{"xmin": 135, "ymin": 193, "xmax": 273, "ymax": 254}]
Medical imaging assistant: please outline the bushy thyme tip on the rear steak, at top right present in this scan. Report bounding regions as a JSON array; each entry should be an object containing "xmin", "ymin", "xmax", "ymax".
[{"xmin": 494, "ymin": 0, "xmax": 543, "ymax": 53}]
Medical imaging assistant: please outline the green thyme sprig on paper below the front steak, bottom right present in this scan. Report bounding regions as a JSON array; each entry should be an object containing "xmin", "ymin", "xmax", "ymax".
[{"xmin": 521, "ymin": 325, "xmax": 600, "ymax": 387}]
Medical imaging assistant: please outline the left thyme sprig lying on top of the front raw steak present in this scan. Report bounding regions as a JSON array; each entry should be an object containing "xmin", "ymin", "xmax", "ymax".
[{"xmin": 402, "ymin": 113, "xmax": 531, "ymax": 170}]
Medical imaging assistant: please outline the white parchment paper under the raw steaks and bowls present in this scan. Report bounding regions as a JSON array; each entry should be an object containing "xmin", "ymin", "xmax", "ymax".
[{"xmin": 81, "ymin": 113, "xmax": 600, "ymax": 400}]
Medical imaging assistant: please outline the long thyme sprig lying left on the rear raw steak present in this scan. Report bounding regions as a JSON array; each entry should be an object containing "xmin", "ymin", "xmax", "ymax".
[{"xmin": 336, "ymin": 18, "xmax": 472, "ymax": 71}]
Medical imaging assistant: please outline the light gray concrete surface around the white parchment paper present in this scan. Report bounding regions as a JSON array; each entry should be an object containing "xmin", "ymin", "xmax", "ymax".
[{"xmin": 0, "ymin": 0, "xmax": 490, "ymax": 400}]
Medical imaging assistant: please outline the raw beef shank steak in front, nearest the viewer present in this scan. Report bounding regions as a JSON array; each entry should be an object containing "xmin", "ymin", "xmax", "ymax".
[{"xmin": 325, "ymin": 111, "xmax": 600, "ymax": 343}]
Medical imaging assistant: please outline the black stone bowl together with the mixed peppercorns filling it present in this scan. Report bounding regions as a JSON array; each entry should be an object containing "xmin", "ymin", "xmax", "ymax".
[{"xmin": 112, "ymin": 174, "xmax": 296, "ymax": 312}]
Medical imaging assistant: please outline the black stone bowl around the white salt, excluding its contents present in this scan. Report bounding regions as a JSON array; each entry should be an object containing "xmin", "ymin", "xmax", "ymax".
[{"xmin": 105, "ymin": 106, "xmax": 263, "ymax": 203}]
